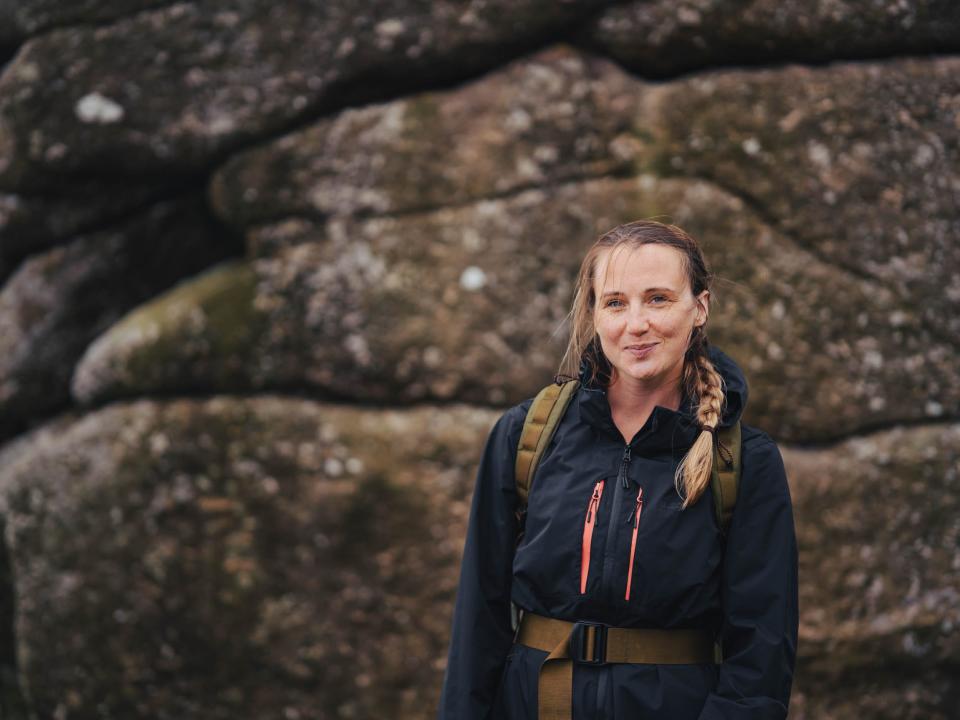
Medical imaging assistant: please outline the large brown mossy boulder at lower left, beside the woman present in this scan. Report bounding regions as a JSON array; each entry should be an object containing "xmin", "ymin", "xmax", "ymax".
[{"xmin": 0, "ymin": 396, "xmax": 502, "ymax": 720}]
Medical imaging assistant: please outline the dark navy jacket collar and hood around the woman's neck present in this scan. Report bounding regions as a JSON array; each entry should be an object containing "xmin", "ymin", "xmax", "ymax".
[{"xmin": 577, "ymin": 346, "xmax": 747, "ymax": 447}]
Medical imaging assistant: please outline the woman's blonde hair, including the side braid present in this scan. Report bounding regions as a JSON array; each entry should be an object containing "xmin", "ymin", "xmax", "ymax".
[{"xmin": 560, "ymin": 220, "xmax": 724, "ymax": 508}]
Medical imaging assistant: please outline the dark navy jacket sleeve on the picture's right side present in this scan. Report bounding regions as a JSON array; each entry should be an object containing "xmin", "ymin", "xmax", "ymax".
[{"xmin": 699, "ymin": 435, "xmax": 799, "ymax": 720}]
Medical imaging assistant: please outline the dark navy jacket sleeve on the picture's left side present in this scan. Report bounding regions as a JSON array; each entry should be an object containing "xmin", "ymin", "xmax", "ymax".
[{"xmin": 437, "ymin": 406, "xmax": 526, "ymax": 720}]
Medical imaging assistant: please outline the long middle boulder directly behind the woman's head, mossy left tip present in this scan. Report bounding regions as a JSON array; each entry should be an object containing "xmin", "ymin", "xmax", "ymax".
[{"xmin": 74, "ymin": 176, "xmax": 960, "ymax": 440}]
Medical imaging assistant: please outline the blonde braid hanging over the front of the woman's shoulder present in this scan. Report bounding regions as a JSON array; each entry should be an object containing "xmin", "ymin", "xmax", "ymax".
[{"xmin": 674, "ymin": 344, "xmax": 724, "ymax": 508}]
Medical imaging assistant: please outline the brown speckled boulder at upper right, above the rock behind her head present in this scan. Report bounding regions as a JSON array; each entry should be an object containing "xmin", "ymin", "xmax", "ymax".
[{"xmin": 637, "ymin": 58, "xmax": 960, "ymax": 346}]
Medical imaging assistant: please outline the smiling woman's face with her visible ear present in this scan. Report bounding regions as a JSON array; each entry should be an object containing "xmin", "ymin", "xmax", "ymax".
[{"xmin": 593, "ymin": 244, "xmax": 709, "ymax": 391}]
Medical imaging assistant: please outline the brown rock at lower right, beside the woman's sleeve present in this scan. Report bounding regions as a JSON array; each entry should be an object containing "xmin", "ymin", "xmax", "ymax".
[{"xmin": 785, "ymin": 425, "xmax": 960, "ymax": 720}]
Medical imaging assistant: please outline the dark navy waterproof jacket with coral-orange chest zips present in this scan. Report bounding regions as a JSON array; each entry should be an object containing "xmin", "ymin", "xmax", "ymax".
[{"xmin": 438, "ymin": 349, "xmax": 798, "ymax": 720}]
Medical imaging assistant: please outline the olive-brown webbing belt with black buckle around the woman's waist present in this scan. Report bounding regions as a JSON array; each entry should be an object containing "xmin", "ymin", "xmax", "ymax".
[{"xmin": 516, "ymin": 613, "xmax": 720, "ymax": 720}]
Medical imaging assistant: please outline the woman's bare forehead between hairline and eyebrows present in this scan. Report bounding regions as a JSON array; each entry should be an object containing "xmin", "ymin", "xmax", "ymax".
[{"xmin": 594, "ymin": 244, "xmax": 689, "ymax": 295}]
